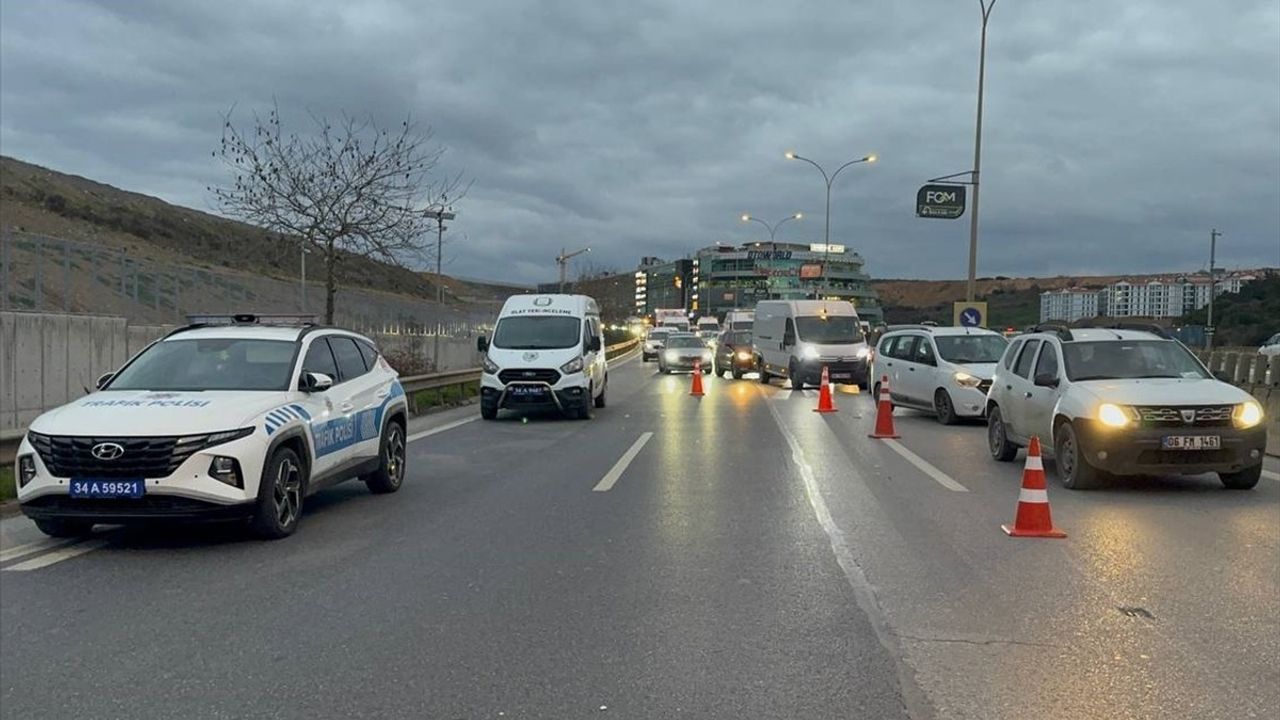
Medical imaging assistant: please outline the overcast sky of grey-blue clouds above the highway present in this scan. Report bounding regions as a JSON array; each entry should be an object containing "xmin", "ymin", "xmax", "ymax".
[{"xmin": 0, "ymin": 0, "xmax": 1280, "ymax": 282}]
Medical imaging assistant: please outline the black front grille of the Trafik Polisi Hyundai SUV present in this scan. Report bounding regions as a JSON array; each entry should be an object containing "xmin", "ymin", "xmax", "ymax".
[{"xmin": 28, "ymin": 433, "xmax": 195, "ymax": 478}]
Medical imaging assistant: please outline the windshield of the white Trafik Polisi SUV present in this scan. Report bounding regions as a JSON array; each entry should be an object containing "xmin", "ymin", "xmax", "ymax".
[{"xmin": 106, "ymin": 338, "xmax": 297, "ymax": 391}]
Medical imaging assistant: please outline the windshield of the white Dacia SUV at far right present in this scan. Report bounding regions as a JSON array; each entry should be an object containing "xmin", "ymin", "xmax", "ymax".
[{"xmin": 1062, "ymin": 340, "xmax": 1210, "ymax": 380}]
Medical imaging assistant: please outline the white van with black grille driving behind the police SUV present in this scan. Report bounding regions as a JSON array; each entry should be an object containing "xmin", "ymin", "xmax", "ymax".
[{"xmin": 476, "ymin": 289, "xmax": 609, "ymax": 420}]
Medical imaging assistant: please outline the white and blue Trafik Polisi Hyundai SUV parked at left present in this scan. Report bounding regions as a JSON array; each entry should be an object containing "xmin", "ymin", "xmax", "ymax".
[{"xmin": 15, "ymin": 315, "xmax": 407, "ymax": 538}]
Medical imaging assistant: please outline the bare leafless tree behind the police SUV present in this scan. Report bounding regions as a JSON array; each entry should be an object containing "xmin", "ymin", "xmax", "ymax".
[{"xmin": 209, "ymin": 101, "xmax": 462, "ymax": 323}]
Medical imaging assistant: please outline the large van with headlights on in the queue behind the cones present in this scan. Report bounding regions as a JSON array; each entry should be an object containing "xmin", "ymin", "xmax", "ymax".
[{"xmin": 751, "ymin": 300, "xmax": 869, "ymax": 389}]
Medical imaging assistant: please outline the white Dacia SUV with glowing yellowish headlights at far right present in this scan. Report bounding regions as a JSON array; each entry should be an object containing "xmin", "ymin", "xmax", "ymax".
[{"xmin": 987, "ymin": 325, "xmax": 1266, "ymax": 489}]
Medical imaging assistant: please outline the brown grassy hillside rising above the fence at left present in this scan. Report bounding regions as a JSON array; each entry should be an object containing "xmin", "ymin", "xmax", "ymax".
[{"xmin": 0, "ymin": 156, "xmax": 519, "ymax": 304}]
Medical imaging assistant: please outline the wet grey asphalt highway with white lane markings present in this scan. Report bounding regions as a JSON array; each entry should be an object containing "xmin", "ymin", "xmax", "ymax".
[{"xmin": 0, "ymin": 353, "xmax": 1280, "ymax": 719}]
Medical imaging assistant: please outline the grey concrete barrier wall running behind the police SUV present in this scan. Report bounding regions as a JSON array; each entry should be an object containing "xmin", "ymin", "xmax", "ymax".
[{"xmin": 0, "ymin": 311, "xmax": 480, "ymax": 439}]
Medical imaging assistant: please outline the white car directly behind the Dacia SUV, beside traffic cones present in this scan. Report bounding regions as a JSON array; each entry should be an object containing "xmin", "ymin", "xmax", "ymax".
[{"xmin": 872, "ymin": 325, "xmax": 1009, "ymax": 425}]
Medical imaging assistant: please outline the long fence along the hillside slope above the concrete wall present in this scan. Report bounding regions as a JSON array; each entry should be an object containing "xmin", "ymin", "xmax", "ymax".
[{"xmin": 0, "ymin": 229, "xmax": 495, "ymax": 338}]
